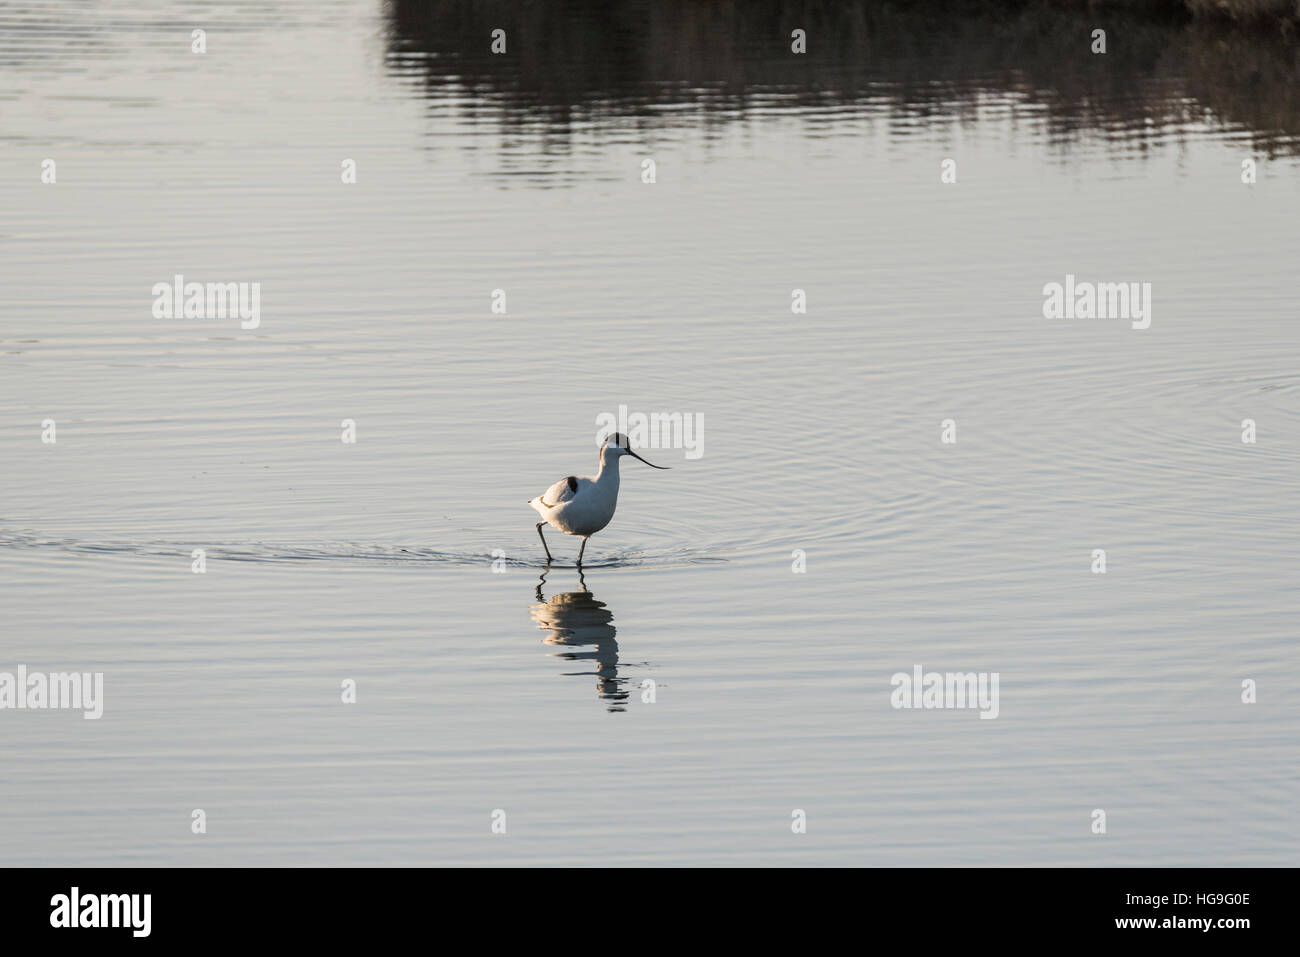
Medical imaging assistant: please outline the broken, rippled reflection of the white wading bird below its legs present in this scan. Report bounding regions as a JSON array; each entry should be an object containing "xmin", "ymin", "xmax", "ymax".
[{"xmin": 529, "ymin": 572, "xmax": 631, "ymax": 711}]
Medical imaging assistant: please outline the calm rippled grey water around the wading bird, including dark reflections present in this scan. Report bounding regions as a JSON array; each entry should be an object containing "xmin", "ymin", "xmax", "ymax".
[{"xmin": 0, "ymin": 0, "xmax": 1300, "ymax": 866}]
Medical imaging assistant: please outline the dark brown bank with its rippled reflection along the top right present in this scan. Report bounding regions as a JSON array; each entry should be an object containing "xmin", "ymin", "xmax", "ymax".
[{"xmin": 385, "ymin": 0, "xmax": 1300, "ymax": 157}]
